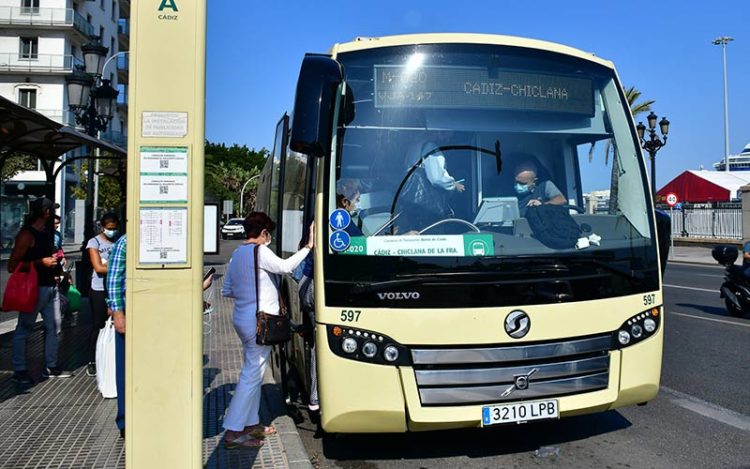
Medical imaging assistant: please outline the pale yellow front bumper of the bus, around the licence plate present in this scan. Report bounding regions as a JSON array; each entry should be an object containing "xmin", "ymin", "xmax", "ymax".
[{"xmin": 317, "ymin": 328, "xmax": 662, "ymax": 433}]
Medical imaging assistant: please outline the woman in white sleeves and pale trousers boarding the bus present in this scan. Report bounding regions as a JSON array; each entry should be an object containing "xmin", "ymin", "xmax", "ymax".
[{"xmin": 221, "ymin": 212, "xmax": 315, "ymax": 448}]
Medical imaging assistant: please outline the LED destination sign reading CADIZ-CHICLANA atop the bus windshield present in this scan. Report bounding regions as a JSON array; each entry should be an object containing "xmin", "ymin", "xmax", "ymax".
[{"xmin": 375, "ymin": 65, "xmax": 594, "ymax": 116}]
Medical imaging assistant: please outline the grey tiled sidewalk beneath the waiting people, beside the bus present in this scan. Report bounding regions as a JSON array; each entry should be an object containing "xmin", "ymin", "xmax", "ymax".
[{"xmin": 0, "ymin": 266, "xmax": 312, "ymax": 469}]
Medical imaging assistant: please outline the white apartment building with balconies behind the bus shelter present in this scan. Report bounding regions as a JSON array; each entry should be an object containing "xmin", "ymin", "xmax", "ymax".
[{"xmin": 0, "ymin": 0, "xmax": 130, "ymax": 245}]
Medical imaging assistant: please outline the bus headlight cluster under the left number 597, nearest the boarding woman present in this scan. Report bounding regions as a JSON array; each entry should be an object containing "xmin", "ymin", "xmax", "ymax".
[{"xmin": 326, "ymin": 325, "xmax": 411, "ymax": 366}]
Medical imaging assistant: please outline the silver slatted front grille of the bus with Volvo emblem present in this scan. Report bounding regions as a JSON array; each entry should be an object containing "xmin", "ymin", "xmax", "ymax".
[{"xmin": 412, "ymin": 334, "xmax": 612, "ymax": 405}]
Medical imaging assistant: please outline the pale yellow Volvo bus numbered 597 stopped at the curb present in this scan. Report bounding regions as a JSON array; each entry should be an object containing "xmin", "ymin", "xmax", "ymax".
[{"xmin": 256, "ymin": 34, "xmax": 668, "ymax": 433}]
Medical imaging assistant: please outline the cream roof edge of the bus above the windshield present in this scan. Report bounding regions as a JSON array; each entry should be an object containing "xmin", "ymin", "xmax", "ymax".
[{"xmin": 330, "ymin": 33, "xmax": 614, "ymax": 68}]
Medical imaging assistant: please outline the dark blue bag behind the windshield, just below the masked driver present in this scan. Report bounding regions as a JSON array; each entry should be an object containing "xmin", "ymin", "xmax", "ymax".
[{"xmin": 526, "ymin": 204, "xmax": 581, "ymax": 249}]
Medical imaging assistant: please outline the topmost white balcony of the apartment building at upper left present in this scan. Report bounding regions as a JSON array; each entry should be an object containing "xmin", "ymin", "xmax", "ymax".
[{"xmin": 0, "ymin": 6, "xmax": 95, "ymax": 38}]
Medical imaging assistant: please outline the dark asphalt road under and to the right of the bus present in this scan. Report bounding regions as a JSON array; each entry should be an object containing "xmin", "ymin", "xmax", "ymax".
[{"xmin": 292, "ymin": 264, "xmax": 750, "ymax": 469}]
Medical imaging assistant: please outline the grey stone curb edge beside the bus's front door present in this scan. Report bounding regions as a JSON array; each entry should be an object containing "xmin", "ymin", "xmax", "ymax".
[{"xmin": 263, "ymin": 368, "xmax": 313, "ymax": 469}]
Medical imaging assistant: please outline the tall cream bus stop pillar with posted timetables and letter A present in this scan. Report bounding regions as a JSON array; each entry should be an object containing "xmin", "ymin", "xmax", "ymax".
[{"xmin": 127, "ymin": 0, "xmax": 206, "ymax": 469}]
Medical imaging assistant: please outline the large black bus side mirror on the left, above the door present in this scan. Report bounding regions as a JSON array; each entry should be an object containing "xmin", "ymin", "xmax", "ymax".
[{"xmin": 289, "ymin": 54, "xmax": 344, "ymax": 156}]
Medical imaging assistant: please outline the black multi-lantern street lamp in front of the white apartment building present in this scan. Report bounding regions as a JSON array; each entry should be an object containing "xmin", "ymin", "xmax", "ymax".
[{"xmin": 66, "ymin": 37, "xmax": 119, "ymax": 239}]
